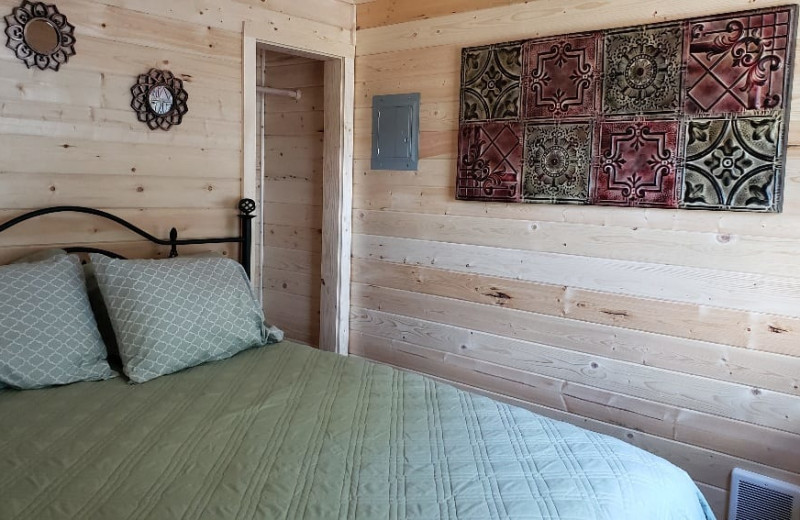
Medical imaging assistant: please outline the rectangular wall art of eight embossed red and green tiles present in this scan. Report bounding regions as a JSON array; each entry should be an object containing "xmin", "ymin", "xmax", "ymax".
[{"xmin": 456, "ymin": 5, "xmax": 797, "ymax": 212}]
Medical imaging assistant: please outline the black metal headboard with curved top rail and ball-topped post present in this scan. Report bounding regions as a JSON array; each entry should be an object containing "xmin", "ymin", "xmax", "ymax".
[{"xmin": 0, "ymin": 199, "xmax": 256, "ymax": 276}]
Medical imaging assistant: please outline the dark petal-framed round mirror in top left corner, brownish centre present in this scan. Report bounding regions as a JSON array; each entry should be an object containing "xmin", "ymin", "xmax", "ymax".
[{"xmin": 5, "ymin": 0, "xmax": 75, "ymax": 70}]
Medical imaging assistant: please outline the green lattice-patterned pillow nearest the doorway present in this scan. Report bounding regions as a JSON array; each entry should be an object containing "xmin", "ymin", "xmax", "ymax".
[{"xmin": 90, "ymin": 254, "xmax": 268, "ymax": 383}]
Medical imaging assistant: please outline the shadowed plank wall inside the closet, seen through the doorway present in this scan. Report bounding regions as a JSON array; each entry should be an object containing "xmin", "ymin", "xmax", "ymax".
[{"xmin": 262, "ymin": 51, "xmax": 324, "ymax": 347}]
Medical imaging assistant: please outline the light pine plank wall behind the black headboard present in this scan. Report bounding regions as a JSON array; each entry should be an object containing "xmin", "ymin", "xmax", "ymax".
[{"xmin": 0, "ymin": 0, "xmax": 355, "ymax": 262}]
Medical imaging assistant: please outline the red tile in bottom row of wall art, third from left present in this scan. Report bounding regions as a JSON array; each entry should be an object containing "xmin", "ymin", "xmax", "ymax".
[{"xmin": 592, "ymin": 121, "xmax": 680, "ymax": 208}]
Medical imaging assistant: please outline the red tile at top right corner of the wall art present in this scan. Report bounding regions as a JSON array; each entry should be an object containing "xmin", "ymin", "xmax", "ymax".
[{"xmin": 685, "ymin": 8, "xmax": 792, "ymax": 114}]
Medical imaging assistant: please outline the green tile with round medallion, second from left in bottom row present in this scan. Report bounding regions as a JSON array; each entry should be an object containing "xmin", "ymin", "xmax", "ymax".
[{"xmin": 523, "ymin": 124, "xmax": 594, "ymax": 204}]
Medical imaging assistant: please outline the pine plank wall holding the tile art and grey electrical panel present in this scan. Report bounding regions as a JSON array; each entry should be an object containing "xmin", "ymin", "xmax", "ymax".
[{"xmin": 351, "ymin": 0, "xmax": 800, "ymax": 515}]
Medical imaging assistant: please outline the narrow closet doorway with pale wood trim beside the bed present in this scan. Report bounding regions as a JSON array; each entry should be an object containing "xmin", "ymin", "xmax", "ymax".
[{"xmin": 242, "ymin": 22, "xmax": 355, "ymax": 354}]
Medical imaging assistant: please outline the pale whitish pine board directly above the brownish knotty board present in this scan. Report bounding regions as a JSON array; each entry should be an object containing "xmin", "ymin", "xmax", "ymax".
[{"xmin": 353, "ymin": 234, "xmax": 800, "ymax": 316}]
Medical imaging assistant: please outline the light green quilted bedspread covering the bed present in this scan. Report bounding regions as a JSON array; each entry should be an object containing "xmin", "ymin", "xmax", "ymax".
[{"xmin": 0, "ymin": 200, "xmax": 714, "ymax": 520}]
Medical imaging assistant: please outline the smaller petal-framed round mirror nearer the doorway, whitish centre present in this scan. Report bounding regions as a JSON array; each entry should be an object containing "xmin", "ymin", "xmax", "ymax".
[{"xmin": 131, "ymin": 69, "xmax": 189, "ymax": 130}]
